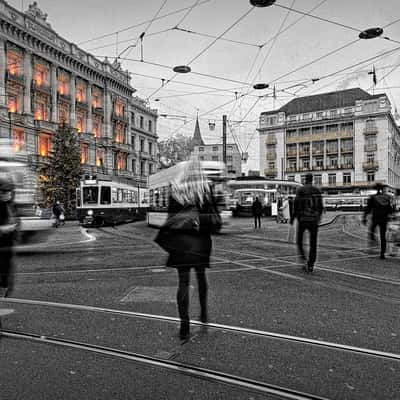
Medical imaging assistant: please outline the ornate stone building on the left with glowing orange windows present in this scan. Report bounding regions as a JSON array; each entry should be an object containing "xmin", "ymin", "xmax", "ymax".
[{"xmin": 0, "ymin": 0, "xmax": 157, "ymax": 187}]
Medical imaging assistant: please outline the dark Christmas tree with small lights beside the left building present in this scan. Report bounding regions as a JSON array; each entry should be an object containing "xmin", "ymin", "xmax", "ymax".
[{"xmin": 39, "ymin": 125, "xmax": 82, "ymax": 216}]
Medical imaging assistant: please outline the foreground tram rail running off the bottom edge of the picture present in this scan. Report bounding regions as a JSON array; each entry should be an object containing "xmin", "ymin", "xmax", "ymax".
[{"xmin": 1, "ymin": 330, "xmax": 329, "ymax": 400}]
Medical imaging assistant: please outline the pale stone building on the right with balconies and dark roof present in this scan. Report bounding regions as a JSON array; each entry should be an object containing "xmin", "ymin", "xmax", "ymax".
[{"xmin": 258, "ymin": 88, "xmax": 400, "ymax": 194}]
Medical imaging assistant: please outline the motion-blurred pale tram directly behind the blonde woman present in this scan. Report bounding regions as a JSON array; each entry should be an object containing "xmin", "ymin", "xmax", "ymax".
[{"xmin": 147, "ymin": 161, "xmax": 232, "ymax": 227}]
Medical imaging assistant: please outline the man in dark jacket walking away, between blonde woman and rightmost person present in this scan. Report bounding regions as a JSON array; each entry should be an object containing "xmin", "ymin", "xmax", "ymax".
[{"xmin": 290, "ymin": 174, "xmax": 323, "ymax": 272}]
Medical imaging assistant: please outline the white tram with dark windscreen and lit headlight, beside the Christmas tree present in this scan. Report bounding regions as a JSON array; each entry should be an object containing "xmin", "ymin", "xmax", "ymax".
[{"xmin": 76, "ymin": 174, "xmax": 149, "ymax": 226}]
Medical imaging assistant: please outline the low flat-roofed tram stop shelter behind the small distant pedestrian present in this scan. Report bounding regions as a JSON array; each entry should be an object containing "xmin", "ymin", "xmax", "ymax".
[{"xmin": 227, "ymin": 176, "xmax": 301, "ymax": 217}]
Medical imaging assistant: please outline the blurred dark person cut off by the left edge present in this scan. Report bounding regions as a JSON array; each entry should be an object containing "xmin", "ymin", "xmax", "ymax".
[{"xmin": 0, "ymin": 173, "xmax": 17, "ymax": 297}]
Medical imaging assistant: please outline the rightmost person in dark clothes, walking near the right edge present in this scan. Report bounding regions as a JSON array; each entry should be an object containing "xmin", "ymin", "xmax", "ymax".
[{"xmin": 363, "ymin": 183, "xmax": 393, "ymax": 260}]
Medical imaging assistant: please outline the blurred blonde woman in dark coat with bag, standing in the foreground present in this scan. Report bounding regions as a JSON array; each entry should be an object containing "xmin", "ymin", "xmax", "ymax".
[{"xmin": 155, "ymin": 161, "xmax": 221, "ymax": 340}]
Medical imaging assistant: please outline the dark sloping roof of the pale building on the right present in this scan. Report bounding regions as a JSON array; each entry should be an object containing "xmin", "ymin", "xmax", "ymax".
[{"xmin": 261, "ymin": 88, "xmax": 382, "ymax": 115}]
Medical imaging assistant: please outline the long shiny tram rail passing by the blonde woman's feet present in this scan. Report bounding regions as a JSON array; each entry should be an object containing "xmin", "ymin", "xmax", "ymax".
[{"xmin": 0, "ymin": 298, "xmax": 400, "ymax": 362}]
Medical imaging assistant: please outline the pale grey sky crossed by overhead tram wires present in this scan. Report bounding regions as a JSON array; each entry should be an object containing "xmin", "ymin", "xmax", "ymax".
[{"xmin": 8, "ymin": 0, "xmax": 400, "ymax": 169}]
